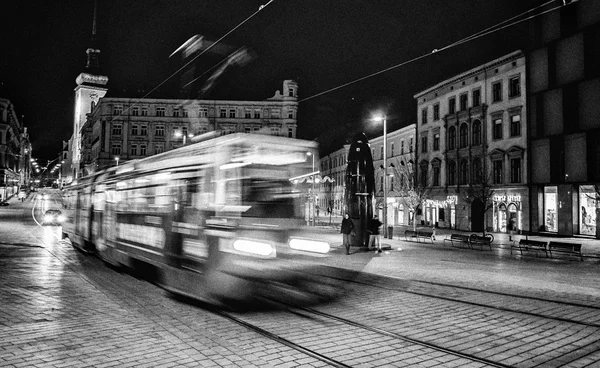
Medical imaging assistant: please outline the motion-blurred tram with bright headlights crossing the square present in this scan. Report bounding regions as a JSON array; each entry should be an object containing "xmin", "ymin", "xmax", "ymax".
[{"xmin": 63, "ymin": 134, "xmax": 330, "ymax": 302}]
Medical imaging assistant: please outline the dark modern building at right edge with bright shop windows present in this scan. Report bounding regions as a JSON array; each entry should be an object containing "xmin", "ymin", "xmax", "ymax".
[{"xmin": 527, "ymin": 1, "xmax": 600, "ymax": 238}]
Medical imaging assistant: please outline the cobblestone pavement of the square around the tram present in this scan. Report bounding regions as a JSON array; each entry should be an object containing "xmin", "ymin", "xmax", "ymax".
[{"xmin": 0, "ymin": 194, "xmax": 600, "ymax": 367}]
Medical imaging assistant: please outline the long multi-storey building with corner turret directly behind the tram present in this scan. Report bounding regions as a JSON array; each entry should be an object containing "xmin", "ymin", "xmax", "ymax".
[{"xmin": 81, "ymin": 80, "xmax": 298, "ymax": 175}]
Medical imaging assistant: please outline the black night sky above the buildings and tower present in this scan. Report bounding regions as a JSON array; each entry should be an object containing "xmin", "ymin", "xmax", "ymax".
[{"xmin": 0, "ymin": 0, "xmax": 554, "ymax": 159}]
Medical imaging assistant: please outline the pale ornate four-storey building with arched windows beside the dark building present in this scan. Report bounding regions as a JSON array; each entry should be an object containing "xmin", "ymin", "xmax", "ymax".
[{"xmin": 414, "ymin": 51, "xmax": 530, "ymax": 232}]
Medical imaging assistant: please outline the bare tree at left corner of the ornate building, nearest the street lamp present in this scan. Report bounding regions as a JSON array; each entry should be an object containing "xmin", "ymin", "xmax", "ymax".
[{"xmin": 390, "ymin": 156, "xmax": 432, "ymax": 230}]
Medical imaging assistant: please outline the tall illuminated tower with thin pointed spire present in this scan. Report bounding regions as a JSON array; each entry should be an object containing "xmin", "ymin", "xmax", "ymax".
[{"xmin": 70, "ymin": 1, "xmax": 108, "ymax": 178}]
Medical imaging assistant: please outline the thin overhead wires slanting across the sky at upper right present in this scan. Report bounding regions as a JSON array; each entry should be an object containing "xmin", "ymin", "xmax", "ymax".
[{"xmin": 298, "ymin": 0, "xmax": 566, "ymax": 103}]
